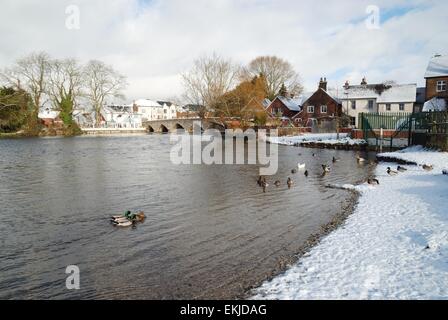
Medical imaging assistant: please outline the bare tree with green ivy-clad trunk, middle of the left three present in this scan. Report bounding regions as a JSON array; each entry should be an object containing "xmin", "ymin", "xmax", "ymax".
[{"xmin": 47, "ymin": 59, "xmax": 83, "ymax": 124}]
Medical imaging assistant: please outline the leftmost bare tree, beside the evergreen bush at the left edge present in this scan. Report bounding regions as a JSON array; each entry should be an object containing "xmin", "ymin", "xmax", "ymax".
[{"xmin": 1, "ymin": 52, "xmax": 50, "ymax": 117}]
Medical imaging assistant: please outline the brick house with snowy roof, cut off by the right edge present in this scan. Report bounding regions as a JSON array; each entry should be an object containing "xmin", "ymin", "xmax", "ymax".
[{"xmin": 425, "ymin": 55, "xmax": 448, "ymax": 109}]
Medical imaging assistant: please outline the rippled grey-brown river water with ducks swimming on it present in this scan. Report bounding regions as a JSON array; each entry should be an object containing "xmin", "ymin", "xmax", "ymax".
[{"xmin": 0, "ymin": 135, "xmax": 369, "ymax": 299}]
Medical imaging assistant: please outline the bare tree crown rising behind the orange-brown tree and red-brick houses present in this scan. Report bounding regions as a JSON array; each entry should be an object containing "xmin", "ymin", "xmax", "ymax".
[{"xmin": 243, "ymin": 56, "xmax": 303, "ymax": 100}]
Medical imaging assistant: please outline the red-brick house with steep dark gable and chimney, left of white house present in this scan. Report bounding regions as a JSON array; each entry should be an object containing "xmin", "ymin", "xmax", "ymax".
[{"xmin": 293, "ymin": 78, "xmax": 342, "ymax": 127}]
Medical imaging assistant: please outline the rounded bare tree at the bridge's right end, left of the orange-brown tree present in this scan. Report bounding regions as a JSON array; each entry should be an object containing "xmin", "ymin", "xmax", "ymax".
[{"xmin": 182, "ymin": 54, "xmax": 240, "ymax": 116}]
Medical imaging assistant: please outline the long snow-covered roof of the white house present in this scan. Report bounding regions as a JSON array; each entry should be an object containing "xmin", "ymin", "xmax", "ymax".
[{"xmin": 341, "ymin": 83, "xmax": 417, "ymax": 103}]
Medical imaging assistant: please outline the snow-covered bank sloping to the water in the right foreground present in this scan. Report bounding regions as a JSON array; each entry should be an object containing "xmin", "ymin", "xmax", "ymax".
[{"xmin": 254, "ymin": 148, "xmax": 448, "ymax": 299}]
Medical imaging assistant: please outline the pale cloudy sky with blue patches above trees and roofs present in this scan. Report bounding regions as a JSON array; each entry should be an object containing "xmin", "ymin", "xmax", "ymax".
[{"xmin": 0, "ymin": 0, "xmax": 448, "ymax": 101}]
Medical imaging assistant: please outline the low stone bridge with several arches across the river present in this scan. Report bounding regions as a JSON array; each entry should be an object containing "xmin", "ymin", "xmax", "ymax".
[{"xmin": 143, "ymin": 118, "xmax": 226, "ymax": 133}]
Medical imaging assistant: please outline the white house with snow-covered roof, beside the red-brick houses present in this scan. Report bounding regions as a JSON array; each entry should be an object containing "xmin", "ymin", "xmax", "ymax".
[{"xmin": 340, "ymin": 78, "xmax": 417, "ymax": 127}]
